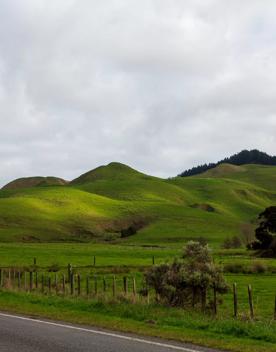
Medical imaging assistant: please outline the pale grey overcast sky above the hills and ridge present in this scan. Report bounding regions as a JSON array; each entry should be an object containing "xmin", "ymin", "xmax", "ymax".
[{"xmin": 0, "ymin": 0, "xmax": 276, "ymax": 184}]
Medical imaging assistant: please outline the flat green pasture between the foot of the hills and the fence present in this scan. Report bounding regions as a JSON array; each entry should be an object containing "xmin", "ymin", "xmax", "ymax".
[{"xmin": 0, "ymin": 243, "xmax": 276, "ymax": 319}]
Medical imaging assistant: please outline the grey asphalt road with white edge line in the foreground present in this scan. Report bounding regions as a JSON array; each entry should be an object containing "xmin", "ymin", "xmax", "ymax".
[{"xmin": 0, "ymin": 313, "xmax": 222, "ymax": 352}]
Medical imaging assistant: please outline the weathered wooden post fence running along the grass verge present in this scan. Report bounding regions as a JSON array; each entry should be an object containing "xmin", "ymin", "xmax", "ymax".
[{"xmin": 0, "ymin": 264, "xmax": 276, "ymax": 320}]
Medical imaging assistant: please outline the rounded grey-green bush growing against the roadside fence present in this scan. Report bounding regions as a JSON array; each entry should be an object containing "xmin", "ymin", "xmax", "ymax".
[{"xmin": 146, "ymin": 241, "xmax": 228, "ymax": 309}]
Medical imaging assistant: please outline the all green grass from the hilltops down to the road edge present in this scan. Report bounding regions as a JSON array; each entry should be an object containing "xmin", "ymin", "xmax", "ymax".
[{"xmin": 0, "ymin": 163, "xmax": 276, "ymax": 352}]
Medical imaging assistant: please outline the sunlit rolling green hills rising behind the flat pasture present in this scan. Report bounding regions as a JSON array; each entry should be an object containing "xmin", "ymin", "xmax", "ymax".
[{"xmin": 0, "ymin": 163, "xmax": 276, "ymax": 246}]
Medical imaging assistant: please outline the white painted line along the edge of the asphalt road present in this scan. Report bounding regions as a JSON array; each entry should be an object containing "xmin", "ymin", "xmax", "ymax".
[{"xmin": 0, "ymin": 313, "xmax": 205, "ymax": 352}]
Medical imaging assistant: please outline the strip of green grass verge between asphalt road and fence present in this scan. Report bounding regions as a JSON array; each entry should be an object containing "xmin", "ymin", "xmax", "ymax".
[{"xmin": 0, "ymin": 291, "xmax": 276, "ymax": 352}]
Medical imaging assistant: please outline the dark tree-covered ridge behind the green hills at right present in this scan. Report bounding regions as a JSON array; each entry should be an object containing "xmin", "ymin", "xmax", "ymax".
[{"xmin": 178, "ymin": 149, "xmax": 276, "ymax": 177}]
